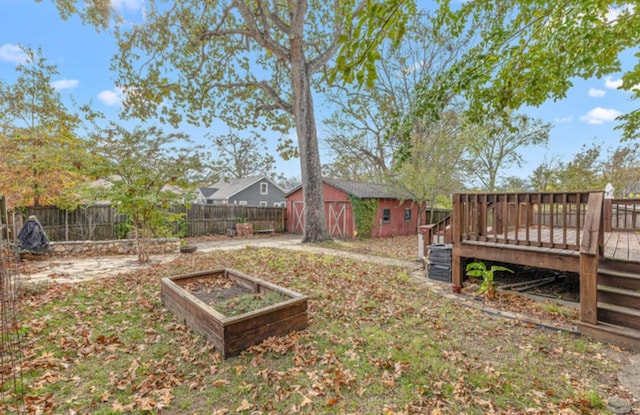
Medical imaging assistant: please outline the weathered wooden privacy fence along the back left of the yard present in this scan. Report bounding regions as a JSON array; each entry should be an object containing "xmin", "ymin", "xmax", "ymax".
[{"xmin": 12, "ymin": 205, "xmax": 286, "ymax": 241}]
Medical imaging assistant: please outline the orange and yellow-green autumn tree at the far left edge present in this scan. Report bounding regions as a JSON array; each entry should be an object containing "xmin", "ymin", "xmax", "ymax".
[{"xmin": 0, "ymin": 49, "xmax": 86, "ymax": 206}]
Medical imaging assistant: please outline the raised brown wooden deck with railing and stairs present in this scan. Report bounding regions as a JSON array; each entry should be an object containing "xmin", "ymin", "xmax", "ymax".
[{"xmin": 420, "ymin": 192, "xmax": 640, "ymax": 349}]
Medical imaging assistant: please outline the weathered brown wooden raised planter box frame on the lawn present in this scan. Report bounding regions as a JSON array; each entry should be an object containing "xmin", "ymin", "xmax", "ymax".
[{"xmin": 161, "ymin": 269, "xmax": 307, "ymax": 358}]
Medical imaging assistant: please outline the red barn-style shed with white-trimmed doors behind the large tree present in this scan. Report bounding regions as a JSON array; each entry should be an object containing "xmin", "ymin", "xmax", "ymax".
[{"xmin": 285, "ymin": 178, "xmax": 418, "ymax": 239}]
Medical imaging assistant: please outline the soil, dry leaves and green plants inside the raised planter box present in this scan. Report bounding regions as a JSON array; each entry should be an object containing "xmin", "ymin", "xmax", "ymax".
[{"xmin": 182, "ymin": 275, "xmax": 287, "ymax": 317}]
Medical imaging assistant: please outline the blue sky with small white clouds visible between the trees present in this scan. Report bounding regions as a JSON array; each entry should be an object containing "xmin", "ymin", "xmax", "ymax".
[{"xmin": 0, "ymin": 0, "xmax": 638, "ymax": 185}]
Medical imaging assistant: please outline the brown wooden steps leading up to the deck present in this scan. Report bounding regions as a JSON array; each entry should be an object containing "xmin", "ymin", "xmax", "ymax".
[{"xmin": 580, "ymin": 259, "xmax": 640, "ymax": 349}]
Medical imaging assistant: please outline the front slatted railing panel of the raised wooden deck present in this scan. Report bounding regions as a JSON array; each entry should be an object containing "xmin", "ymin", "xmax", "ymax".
[{"xmin": 452, "ymin": 192, "xmax": 589, "ymax": 251}]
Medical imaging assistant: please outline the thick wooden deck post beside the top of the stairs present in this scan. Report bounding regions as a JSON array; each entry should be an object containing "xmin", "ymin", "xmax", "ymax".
[{"xmin": 580, "ymin": 192, "xmax": 604, "ymax": 324}]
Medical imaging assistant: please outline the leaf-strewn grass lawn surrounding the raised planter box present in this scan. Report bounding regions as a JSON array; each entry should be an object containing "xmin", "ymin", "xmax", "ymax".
[{"xmin": 7, "ymin": 249, "xmax": 638, "ymax": 414}]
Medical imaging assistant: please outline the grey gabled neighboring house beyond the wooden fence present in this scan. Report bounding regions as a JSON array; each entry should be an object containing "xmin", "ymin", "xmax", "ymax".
[{"xmin": 196, "ymin": 176, "xmax": 286, "ymax": 207}]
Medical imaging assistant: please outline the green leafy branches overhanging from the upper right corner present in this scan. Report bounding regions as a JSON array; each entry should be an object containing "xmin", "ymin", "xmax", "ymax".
[{"xmin": 418, "ymin": 0, "xmax": 640, "ymax": 139}]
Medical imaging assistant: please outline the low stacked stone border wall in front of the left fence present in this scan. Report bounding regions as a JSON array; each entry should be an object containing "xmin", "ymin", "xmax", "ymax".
[{"xmin": 48, "ymin": 238, "xmax": 180, "ymax": 256}]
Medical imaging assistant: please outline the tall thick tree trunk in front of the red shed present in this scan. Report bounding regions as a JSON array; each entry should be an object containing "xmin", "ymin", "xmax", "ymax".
[{"xmin": 290, "ymin": 0, "xmax": 331, "ymax": 242}]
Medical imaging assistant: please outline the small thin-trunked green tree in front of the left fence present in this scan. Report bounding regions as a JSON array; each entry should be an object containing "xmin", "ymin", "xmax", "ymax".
[{"xmin": 89, "ymin": 122, "xmax": 204, "ymax": 262}]
